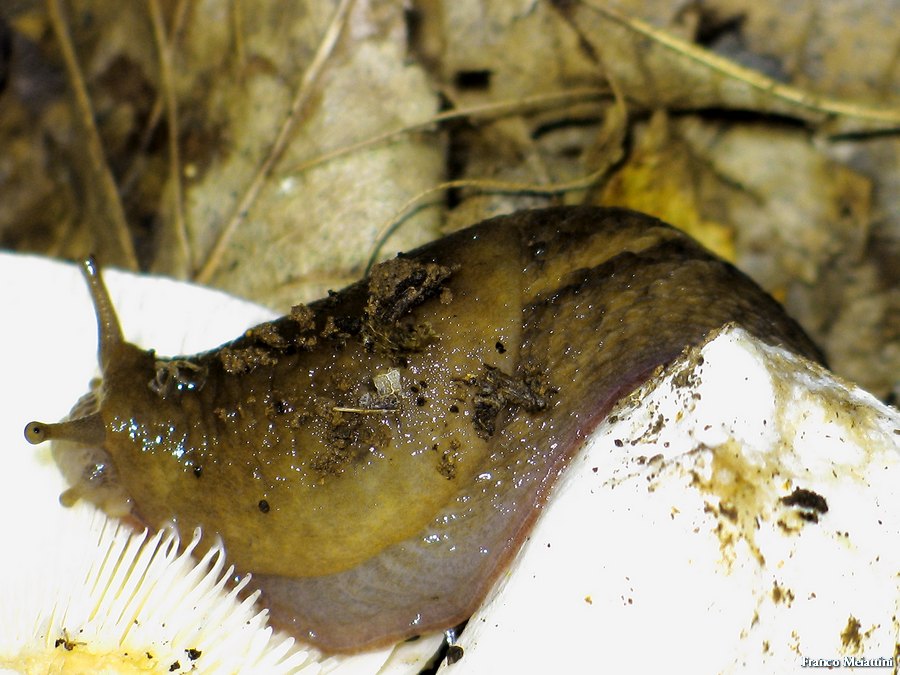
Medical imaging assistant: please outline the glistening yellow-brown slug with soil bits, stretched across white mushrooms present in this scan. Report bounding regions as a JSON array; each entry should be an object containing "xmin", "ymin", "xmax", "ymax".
[{"xmin": 25, "ymin": 207, "xmax": 821, "ymax": 652}]
